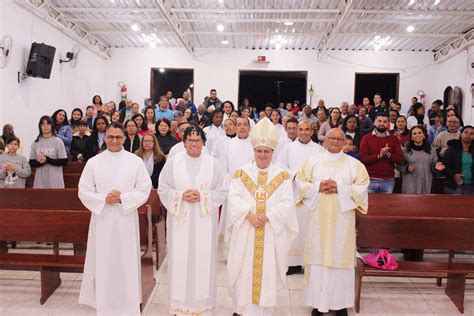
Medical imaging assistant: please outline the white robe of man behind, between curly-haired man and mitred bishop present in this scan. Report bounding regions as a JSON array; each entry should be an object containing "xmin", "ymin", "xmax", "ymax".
[{"xmin": 218, "ymin": 137, "xmax": 254, "ymax": 261}]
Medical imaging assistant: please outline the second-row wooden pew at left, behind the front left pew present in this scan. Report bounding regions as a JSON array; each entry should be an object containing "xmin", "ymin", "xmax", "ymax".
[{"xmin": 0, "ymin": 188, "xmax": 166, "ymax": 269}]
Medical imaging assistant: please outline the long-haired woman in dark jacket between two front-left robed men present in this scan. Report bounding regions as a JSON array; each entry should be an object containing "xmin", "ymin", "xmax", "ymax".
[{"xmin": 135, "ymin": 134, "xmax": 166, "ymax": 189}]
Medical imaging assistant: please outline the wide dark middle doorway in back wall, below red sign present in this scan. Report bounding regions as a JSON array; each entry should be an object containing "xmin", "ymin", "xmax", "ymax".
[{"xmin": 239, "ymin": 70, "xmax": 308, "ymax": 110}]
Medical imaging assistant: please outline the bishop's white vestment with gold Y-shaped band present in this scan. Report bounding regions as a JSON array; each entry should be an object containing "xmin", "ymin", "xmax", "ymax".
[{"xmin": 226, "ymin": 162, "xmax": 298, "ymax": 316}]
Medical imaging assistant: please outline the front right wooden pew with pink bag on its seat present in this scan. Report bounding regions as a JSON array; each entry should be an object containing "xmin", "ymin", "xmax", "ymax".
[{"xmin": 355, "ymin": 194, "xmax": 474, "ymax": 313}]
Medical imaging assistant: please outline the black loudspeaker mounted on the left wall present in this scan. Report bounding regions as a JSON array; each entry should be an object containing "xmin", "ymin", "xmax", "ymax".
[{"xmin": 26, "ymin": 42, "xmax": 56, "ymax": 79}]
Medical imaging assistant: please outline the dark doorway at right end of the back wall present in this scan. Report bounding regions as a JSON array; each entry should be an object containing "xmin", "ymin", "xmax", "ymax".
[{"xmin": 354, "ymin": 73, "xmax": 400, "ymax": 105}]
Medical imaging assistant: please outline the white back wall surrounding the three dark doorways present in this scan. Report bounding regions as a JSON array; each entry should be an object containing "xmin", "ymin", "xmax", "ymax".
[{"xmin": 105, "ymin": 48, "xmax": 442, "ymax": 115}]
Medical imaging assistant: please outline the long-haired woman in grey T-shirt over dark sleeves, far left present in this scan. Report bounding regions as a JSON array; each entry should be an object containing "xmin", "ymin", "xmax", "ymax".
[{"xmin": 30, "ymin": 115, "xmax": 67, "ymax": 189}]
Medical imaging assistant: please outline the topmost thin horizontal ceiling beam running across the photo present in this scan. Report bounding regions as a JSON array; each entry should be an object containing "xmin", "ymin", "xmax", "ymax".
[{"xmin": 57, "ymin": 7, "xmax": 474, "ymax": 16}]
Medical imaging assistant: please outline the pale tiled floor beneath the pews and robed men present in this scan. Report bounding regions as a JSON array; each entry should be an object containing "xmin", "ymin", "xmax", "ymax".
[{"xmin": 0, "ymin": 248, "xmax": 474, "ymax": 316}]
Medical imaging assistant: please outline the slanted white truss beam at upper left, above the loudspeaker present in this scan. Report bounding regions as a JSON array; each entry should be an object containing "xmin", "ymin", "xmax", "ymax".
[{"xmin": 14, "ymin": 0, "xmax": 112, "ymax": 59}]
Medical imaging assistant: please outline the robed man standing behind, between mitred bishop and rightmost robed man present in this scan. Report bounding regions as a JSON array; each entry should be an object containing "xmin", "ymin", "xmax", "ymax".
[{"xmin": 277, "ymin": 120, "xmax": 324, "ymax": 275}]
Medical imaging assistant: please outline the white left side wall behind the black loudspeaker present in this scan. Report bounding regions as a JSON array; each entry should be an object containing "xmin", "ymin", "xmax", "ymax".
[{"xmin": 0, "ymin": 0, "xmax": 105, "ymax": 154}]
